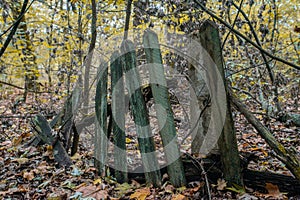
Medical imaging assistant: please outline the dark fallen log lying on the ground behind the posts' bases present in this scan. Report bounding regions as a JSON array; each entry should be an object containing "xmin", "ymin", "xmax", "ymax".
[{"xmin": 120, "ymin": 156, "xmax": 300, "ymax": 197}]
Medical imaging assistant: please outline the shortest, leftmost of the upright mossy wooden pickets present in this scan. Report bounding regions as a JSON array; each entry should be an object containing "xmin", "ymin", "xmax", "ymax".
[{"xmin": 95, "ymin": 63, "xmax": 108, "ymax": 176}]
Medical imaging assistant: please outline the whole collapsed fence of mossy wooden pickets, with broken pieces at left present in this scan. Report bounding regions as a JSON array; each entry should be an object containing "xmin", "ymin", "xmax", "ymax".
[{"xmin": 31, "ymin": 21, "xmax": 300, "ymax": 191}]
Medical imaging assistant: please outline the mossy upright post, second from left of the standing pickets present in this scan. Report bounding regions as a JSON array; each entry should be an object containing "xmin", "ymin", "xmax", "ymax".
[{"xmin": 110, "ymin": 51, "xmax": 128, "ymax": 183}]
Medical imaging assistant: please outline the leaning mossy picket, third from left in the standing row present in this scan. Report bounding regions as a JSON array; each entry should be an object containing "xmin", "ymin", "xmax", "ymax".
[{"xmin": 121, "ymin": 40, "xmax": 161, "ymax": 187}]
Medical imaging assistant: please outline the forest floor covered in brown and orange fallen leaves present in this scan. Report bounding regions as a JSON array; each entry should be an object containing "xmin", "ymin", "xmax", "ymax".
[{"xmin": 0, "ymin": 90, "xmax": 300, "ymax": 200}]
